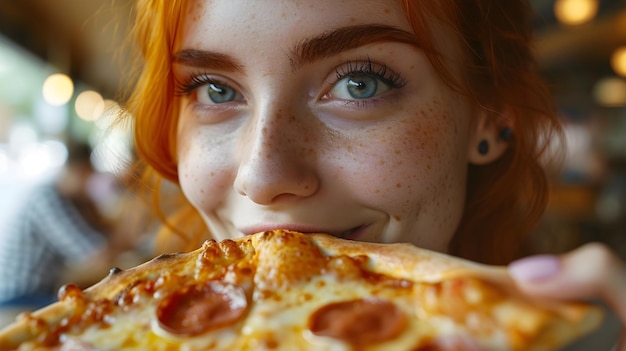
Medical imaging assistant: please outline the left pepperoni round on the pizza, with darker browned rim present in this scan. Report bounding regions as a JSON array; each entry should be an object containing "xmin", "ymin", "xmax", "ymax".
[{"xmin": 156, "ymin": 282, "xmax": 248, "ymax": 336}]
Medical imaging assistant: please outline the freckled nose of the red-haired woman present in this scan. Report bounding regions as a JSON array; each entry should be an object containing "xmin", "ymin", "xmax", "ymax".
[{"xmin": 234, "ymin": 107, "xmax": 319, "ymax": 205}]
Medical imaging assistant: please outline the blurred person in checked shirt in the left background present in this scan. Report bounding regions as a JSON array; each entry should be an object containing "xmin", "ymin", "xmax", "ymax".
[{"xmin": 0, "ymin": 144, "xmax": 129, "ymax": 324}]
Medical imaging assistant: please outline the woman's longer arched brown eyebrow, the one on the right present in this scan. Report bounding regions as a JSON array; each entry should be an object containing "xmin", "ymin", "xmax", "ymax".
[{"xmin": 289, "ymin": 24, "xmax": 419, "ymax": 70}]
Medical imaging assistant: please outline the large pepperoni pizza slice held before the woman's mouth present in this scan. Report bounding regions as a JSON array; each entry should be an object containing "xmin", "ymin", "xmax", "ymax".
[{"xmin": 0, "ymin": 230, "xmax": 602, "ymax": 351}]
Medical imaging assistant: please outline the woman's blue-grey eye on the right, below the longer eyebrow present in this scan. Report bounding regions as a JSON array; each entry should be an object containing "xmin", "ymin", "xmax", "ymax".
[{"xmin": 329, "ymin": 73, "xmax": 391, "ymax": 100}]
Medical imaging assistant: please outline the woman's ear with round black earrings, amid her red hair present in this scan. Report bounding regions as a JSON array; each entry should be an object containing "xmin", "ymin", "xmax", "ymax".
[{"xmin": 468, "ymin": 110, "xmax": 512, "ymax": 165}]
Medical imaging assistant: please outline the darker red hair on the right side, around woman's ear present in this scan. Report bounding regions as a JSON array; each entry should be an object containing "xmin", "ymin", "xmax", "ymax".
[{"xmin": 404, "ymin": 0, "xmax": 562, "ymax": 264}]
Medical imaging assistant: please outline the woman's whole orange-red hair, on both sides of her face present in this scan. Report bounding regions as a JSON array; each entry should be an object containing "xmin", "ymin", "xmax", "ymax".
[{"xmin": 127, "ymin": 0, "xmax": 560, "ymax": 264}]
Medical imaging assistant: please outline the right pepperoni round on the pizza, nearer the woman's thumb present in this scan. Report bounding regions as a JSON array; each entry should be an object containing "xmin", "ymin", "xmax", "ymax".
[{"xmin": 309, "ymin": 298, "xmax": 407, "ymax": 345}]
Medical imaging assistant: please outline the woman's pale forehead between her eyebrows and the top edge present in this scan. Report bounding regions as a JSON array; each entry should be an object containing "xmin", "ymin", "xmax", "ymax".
[{"xmin": 177, "ymin": 0, "xmax": 412, "ymax": 47}]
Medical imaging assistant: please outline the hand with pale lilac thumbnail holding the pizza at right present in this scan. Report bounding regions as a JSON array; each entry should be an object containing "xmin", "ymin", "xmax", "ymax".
[{"xmin": 509, "ymin": 243, "xmax": 626, "ymax": 351}]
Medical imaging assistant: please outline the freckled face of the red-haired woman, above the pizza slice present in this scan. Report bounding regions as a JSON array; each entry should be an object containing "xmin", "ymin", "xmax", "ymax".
[{"xmin": 174, "ymin": 0, "xmax": 474, "ymax": 251}]
